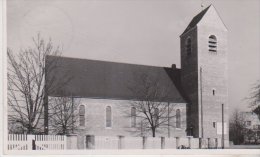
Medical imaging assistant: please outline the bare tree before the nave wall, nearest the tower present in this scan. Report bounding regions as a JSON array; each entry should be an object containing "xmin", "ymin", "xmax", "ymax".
[{"xmin": 129, "ymin": 72, "xmax": 181, "ymax": 137}]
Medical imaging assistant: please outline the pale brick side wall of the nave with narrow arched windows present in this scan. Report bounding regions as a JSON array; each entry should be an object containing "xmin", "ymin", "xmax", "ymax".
[{"xmin": 47, "ymin": 98, "xmax": 186, "ymax": 148}]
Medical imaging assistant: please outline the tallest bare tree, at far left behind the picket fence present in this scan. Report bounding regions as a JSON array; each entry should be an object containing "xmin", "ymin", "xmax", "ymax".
[{"xmin": 7, "ymin": 34, "xmax": 66, "ymax": 133}]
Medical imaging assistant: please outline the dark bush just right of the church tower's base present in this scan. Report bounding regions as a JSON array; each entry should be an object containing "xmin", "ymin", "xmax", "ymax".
[{"xmin": 229, "ymin": 109, "xmax": 247, "ymax": 144}]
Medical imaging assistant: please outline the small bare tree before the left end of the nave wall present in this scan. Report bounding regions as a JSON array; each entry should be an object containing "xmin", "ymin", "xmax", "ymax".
[{"xmin": 49, "ymin": 97, "xmax": 80, "ymax": 135}]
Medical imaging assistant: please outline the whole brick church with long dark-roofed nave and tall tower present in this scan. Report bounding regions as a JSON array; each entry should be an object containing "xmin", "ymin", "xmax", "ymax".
[{"xmin": 45, "ymin": 5, "xmax": 228, "ymax": 145}]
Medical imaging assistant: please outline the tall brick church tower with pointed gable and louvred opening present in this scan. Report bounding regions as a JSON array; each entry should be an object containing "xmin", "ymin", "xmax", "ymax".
[{"xmin": 180, "ymin": 5, "xmax": 228, "ymax": 140}]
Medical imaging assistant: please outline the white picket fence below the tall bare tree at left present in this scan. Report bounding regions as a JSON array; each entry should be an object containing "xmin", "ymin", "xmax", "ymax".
[{"xmin": 7, "ymin": 134, "xmax": 67, "ymax": 150}]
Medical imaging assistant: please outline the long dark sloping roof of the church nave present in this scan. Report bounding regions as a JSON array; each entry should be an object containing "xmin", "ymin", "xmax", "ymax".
[{"xmin": 46, "ymin": 56, "xmax": 185, "ymax": 103}]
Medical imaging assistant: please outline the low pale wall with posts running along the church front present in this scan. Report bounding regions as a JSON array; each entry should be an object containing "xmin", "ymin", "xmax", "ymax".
[{"xmin": 67, "ymin": 135, "xmax": 229, "ymax": 149}]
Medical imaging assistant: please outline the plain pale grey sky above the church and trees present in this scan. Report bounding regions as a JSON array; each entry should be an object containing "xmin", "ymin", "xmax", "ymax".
[{"xmin": 7, "ymin": 0, "xmax": 260, "ymax": 112}]
